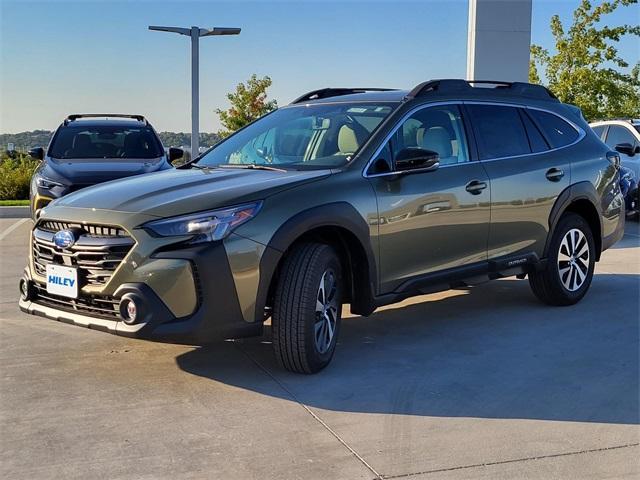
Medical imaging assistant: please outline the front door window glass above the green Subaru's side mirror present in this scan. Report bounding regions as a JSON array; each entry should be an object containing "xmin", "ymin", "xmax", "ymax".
[{"xmin": 392, "ymin": 105, "xmax": 469, "ymax": 165}]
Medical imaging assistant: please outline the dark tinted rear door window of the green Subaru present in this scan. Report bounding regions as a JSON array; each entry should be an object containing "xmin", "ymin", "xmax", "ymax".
[{"xmin": 468, "ymin": 105, "xmax": 531, "ymax": 159}]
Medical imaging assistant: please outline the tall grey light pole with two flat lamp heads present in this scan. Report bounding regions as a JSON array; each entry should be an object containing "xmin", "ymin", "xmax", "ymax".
[{"xmin": 149, "ymin": 25, "xmax": 240, "ymax": 158}]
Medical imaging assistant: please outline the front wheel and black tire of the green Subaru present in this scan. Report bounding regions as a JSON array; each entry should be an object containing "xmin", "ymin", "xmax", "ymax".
[{"xmin": 271, "ymin": 243, "xmax": 343, "ymax": 374}]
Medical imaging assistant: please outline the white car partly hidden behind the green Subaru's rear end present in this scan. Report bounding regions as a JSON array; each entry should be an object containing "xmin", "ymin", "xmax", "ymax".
[{"xmin": 589, "ymin": 119, "xmax": 640, "ymax": 179}]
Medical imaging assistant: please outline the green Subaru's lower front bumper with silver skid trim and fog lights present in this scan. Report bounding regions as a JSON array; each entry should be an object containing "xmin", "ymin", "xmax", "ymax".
[{"xmin": 19, "ymin": 235, "xmax": 262, "ymax": 344}]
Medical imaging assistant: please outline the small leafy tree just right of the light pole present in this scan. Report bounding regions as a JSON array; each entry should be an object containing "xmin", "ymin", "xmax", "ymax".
[{"xmin": 216, "ymin": 73, "xmax": 278, "ymax": 138}]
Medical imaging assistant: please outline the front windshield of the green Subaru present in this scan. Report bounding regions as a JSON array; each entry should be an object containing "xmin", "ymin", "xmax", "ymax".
[{"xmin": 197, "ymin": 103, "xmax": 396, "ymax": 169}]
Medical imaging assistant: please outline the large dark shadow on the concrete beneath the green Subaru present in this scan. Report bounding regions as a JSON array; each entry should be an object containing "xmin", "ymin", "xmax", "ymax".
[{"xmin": 176, "ymin": 274, "xmax": 640, "ymax": 424}]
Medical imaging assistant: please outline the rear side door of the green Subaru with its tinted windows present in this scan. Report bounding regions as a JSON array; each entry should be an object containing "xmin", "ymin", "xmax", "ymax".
[{"xmin": 465, "ymin": 103, "xmax": 579, "ymax": 260}]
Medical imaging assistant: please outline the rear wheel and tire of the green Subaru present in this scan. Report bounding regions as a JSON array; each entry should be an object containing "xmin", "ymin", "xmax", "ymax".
[{"xmin": 529, "ymin": 213, "xmax": 595, "ymax": 306}]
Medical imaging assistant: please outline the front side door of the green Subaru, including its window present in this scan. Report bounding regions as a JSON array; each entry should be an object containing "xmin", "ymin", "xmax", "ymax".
[{"xmin": 368, "ymin": 104, "xmax": 490, "ymax": 293}]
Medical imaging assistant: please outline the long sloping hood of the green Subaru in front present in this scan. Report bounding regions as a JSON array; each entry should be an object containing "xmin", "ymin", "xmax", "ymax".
[{"xmin": 55, "ymin": 168, "xmax": 331, "ymax": 217}]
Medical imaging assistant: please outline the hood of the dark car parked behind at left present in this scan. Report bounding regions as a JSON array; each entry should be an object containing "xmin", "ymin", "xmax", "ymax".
[{"xmin": 42, "ymin": 157, "xmax": 164, "ymax": 185}]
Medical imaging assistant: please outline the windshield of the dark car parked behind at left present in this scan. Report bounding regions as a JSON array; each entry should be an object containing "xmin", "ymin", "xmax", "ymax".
[{"xmin": 49, "ymin": 124, "xmax": 164, "ymax": 159}]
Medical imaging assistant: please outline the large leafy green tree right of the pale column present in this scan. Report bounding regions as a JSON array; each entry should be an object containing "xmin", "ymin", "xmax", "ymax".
[{"xmin": 529, "ymin": 0, "xmax": 640, "ymax": 120}]
